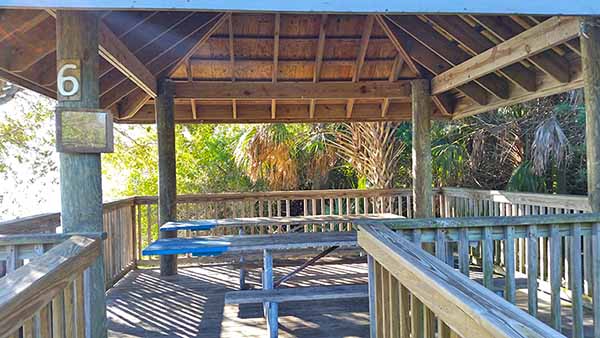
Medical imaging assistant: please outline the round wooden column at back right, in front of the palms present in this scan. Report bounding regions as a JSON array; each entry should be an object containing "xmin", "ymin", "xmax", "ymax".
[{"xmin": 411, "ymin": 80, "xmax": 433, "ymax": 218}]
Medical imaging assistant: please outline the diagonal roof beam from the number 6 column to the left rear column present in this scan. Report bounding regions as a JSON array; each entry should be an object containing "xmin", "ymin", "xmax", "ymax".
[{"xmin": 98, "ymin": 24, "xmax": 156, "ymax": 97}]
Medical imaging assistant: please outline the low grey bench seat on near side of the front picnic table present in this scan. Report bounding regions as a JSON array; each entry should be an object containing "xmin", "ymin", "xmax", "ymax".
[{"xmin": 225, "ymin": 284, "xmax": 369, "ymax": 304}]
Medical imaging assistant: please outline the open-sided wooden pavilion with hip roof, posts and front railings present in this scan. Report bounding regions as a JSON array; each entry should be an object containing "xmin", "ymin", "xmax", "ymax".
[{"xmin": 0, "ymin": 0, "xmax": 600, "ymax": 337}]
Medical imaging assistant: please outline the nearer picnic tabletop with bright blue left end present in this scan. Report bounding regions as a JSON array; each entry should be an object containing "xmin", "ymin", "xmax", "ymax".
[{"xmin": 142, "ymin": 232, "xmax": 356, "ymax": 256}]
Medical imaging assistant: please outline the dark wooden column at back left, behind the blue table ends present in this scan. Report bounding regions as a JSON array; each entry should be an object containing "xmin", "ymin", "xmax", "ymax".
[{"xmin": 156, "ymin": 79, "xmax": 177, "ymax": 276}]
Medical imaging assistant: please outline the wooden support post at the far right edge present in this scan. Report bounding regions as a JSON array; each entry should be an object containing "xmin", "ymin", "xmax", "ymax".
[{"xmin": 580, "ymin": 17, "xmax": 600, "ymax": 337}]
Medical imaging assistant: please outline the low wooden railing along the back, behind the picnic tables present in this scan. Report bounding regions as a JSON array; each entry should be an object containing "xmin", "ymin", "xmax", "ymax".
[{"xmin": 135, "ymin": 189, "xmax": 412, "ymax": 262}]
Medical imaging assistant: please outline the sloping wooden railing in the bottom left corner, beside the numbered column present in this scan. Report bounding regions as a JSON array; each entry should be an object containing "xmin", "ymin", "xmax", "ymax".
[{"xmin": 0, "ymin": 235, "xmax": 101, "ymax": 338}]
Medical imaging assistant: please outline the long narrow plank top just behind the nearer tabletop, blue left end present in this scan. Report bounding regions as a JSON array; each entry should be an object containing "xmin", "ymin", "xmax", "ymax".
[{"xmin": 160, "ymin": 213, "xmax": 402, "ymax": 231}]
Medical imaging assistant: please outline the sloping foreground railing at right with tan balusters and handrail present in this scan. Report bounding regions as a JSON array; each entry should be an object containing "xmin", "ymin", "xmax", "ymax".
[{"xmin": 358, "ymin": 224, "xmax": 563, "ymax": 338}]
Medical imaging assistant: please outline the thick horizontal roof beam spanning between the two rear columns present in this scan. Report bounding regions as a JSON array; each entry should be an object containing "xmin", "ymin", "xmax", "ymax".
[{"xmin": 175, "ymin": 81, "xmax": 410, "ymax": 100}]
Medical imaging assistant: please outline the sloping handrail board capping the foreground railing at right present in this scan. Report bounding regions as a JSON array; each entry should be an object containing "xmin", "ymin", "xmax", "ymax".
[{"xmin": 358, "ymin": 224, "xmax": 564, "ymax": 338}]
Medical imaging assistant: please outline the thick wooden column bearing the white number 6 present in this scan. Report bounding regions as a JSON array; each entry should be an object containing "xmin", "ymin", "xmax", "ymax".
[{"xmin": 56, "ymin": 11, "xmax": 107, "ymax": 338}]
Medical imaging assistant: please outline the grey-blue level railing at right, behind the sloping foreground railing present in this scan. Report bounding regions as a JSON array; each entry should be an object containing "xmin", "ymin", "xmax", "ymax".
[{"xmin": 370, "ymin": 213, "xmax": 600, "ymax": 337}]
